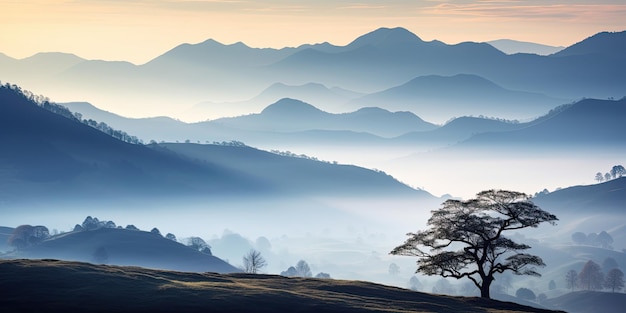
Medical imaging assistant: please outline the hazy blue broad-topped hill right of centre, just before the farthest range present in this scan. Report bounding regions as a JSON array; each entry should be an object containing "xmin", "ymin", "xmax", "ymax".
[{"xmin": 347, "ymin": 74, "xmax": 563, "ymax": 120}]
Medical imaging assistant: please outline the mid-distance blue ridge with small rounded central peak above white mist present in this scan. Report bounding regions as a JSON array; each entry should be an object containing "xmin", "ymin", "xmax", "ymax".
[{"xmin": 63, "ymin": 98, "xmax": 626, "ymax": 148}]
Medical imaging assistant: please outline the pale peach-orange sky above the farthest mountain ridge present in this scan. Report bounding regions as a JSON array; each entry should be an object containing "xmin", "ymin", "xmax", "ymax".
[{"xmin": 0, "ymin": 0, "xmax": 626, "ymax": 64}]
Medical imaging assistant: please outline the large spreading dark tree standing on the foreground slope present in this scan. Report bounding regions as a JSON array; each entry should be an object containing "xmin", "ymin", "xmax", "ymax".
[{"xmin": 391, "ymin": 190, "xmax": 558, "ymax": 298}]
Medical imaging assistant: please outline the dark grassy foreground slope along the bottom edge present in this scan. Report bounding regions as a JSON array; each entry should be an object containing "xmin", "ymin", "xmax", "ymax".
[{"xmin": 0, "ymin": 260, "xmax": 551, "ymax": 313}]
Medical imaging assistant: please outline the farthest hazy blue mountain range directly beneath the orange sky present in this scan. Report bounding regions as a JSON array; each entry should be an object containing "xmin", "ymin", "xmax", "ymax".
[{"xmin": 0, "ymin": 28, "xmax": 626, "ymax": 121}]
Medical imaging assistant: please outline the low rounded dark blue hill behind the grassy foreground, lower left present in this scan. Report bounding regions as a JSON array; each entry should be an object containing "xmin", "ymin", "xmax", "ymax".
[{"xmin": 11, "ymin": 228, "xmax": 239, "ymax": 273}]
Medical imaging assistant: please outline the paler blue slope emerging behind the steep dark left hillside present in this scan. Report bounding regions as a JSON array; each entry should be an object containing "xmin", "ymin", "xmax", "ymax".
[{"xmin": 160, "ymin": 143, "xmax": 432, "ymax": 199}]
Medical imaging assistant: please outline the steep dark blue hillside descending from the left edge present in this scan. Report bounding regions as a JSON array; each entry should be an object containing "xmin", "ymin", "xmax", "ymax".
[{"xmin": 0, "ymin": 86, "xmax": 262, "ymax": 199}]
